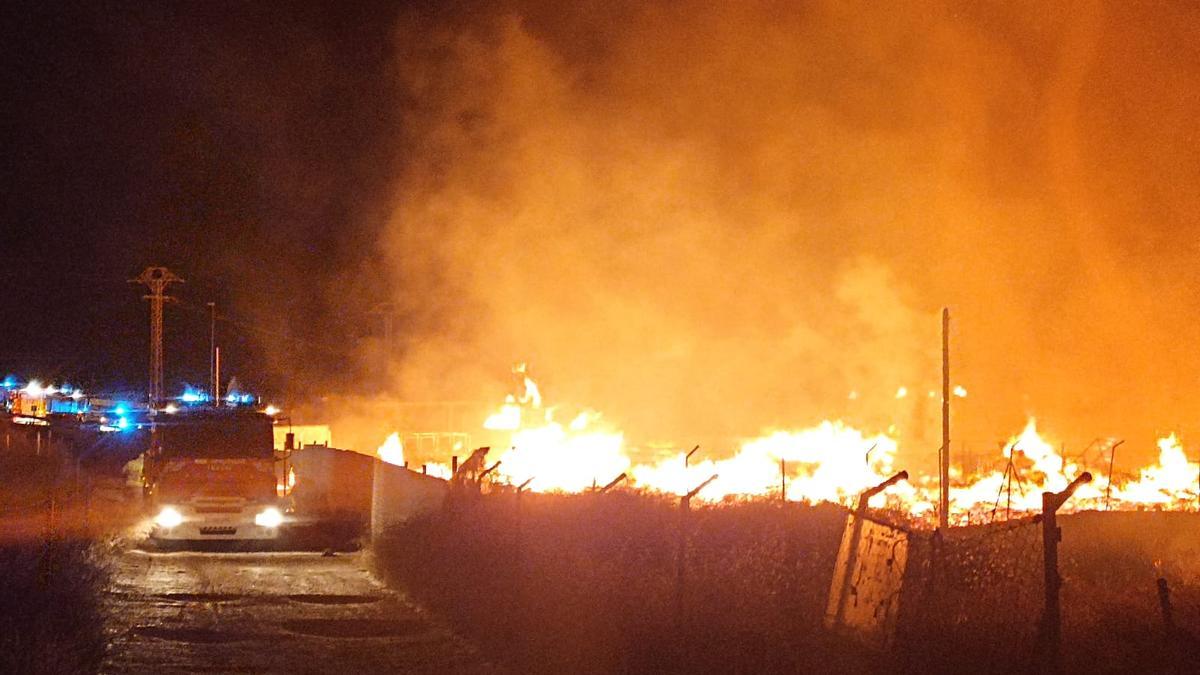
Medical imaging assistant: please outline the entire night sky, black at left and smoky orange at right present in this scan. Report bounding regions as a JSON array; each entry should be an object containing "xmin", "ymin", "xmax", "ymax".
[{"xmin": 7, "ymin": 0, "xmax": 1200, "ymax": 452}]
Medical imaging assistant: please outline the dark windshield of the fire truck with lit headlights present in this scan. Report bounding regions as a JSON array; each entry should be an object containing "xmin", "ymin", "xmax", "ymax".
[{"xmin": 156, "ymin": 416, "xmax": 274, "ymax": 459}]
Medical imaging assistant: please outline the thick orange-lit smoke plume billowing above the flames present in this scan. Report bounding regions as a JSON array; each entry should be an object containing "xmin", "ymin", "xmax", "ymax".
[{"xmin": 374, "ymin": 1, "xmax": 1200, "ymax": 466}]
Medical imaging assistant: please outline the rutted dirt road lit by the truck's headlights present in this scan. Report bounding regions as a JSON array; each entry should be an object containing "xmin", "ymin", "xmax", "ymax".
[{"xmin": 103, "ymin": 550, "xmax": 496, "ymax": 674}]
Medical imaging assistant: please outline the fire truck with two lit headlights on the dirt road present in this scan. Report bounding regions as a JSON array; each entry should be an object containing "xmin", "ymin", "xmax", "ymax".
[{"xmin": 142, "ymin": 407, "xmax": 287, "ymax": 540}]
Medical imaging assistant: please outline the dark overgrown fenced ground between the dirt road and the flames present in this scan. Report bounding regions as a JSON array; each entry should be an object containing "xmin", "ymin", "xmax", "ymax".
[{"xmin": 376, "ymin": 475, "xmax": 1200, "ymax": 673}]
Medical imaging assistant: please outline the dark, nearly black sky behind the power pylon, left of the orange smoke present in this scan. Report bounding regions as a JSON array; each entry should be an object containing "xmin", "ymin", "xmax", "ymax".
[{"xmin": 0, "ymin": 1, "xmax": 398, "ymax": 392}]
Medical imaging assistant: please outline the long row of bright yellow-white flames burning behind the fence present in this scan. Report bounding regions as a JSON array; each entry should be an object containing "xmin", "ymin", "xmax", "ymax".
[{"xmin": 379, "ymin": 365, "xmax": 1200, "ymax": 524}]
